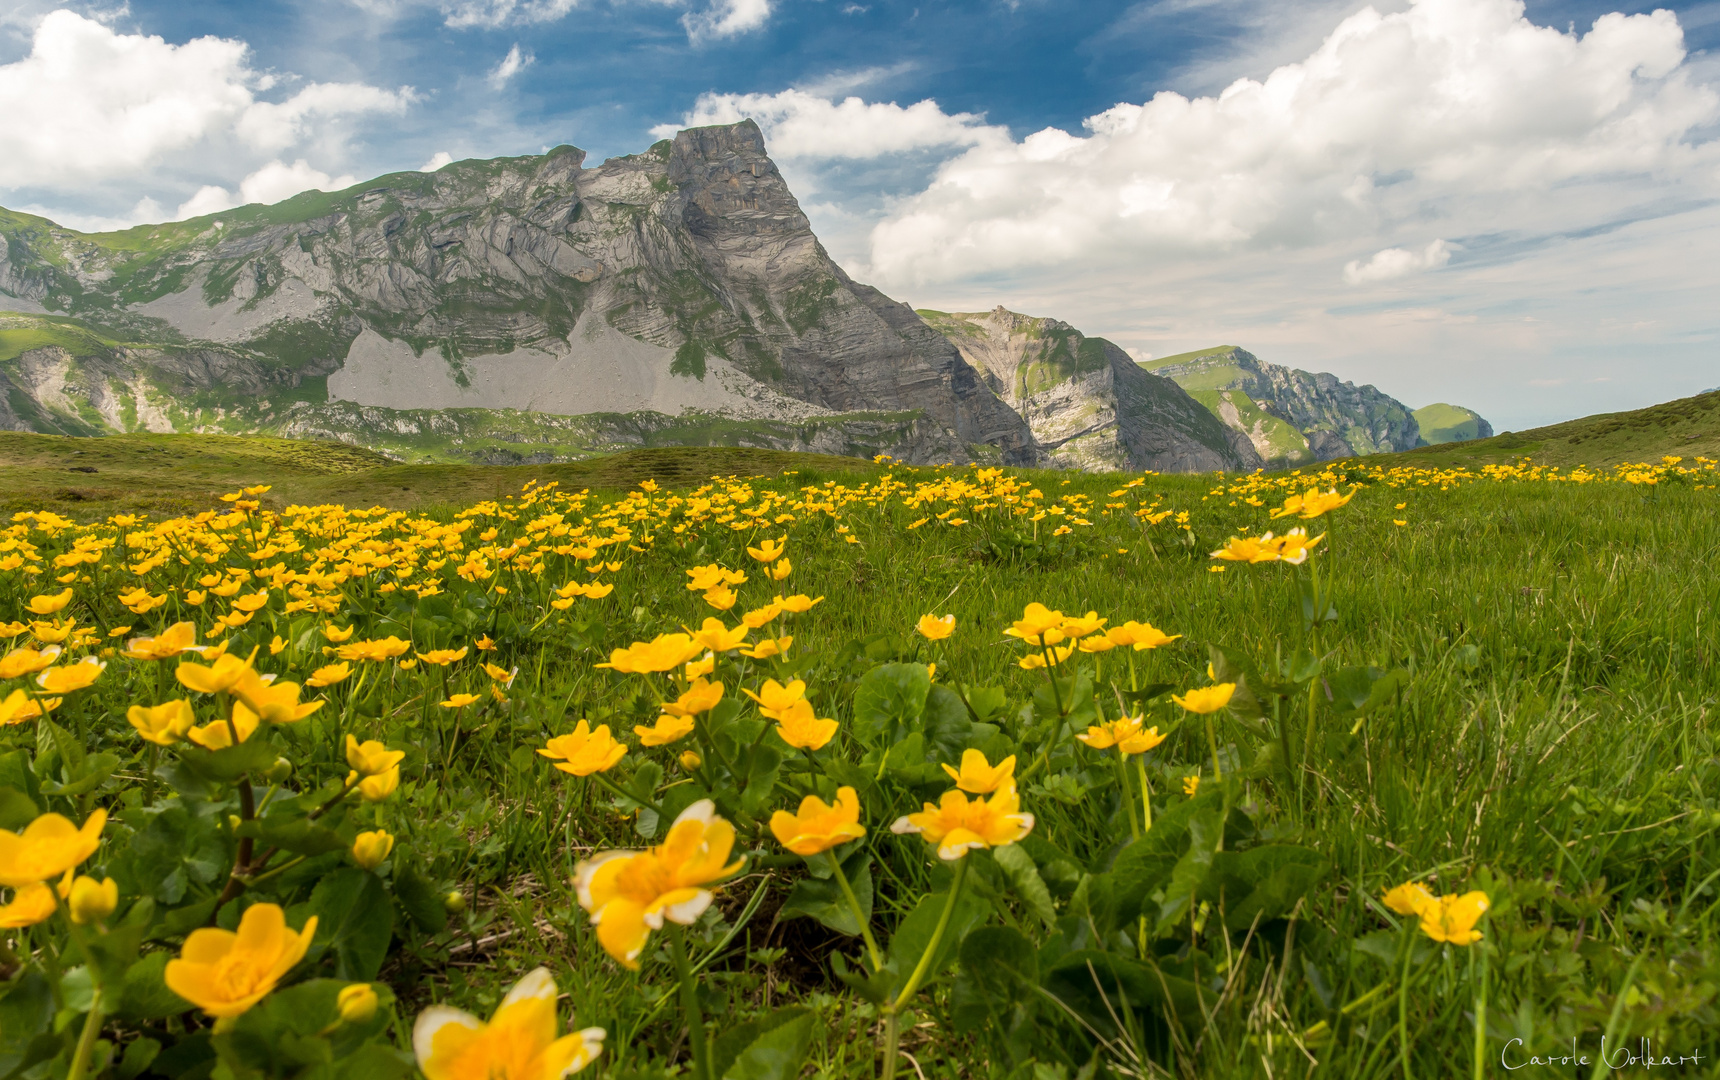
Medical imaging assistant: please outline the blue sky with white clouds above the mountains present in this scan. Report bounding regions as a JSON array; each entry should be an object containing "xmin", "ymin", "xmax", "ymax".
[{"xmin": 0, "ymin": 0, "xmax": 1720, "ymax": 430}]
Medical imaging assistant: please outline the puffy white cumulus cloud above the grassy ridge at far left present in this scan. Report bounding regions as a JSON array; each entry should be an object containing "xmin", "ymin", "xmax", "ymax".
[{"xmin": 0, "ymin": 10, "xmax": 416, "ymax": 224}]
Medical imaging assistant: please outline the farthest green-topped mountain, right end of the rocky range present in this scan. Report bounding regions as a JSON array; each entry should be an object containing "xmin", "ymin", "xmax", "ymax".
[{"xmin": 1140, "ymin": 346, "xmax": 1444, "ymax": 468}]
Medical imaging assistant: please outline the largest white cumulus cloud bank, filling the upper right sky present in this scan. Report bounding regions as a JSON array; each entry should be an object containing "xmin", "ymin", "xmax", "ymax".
[{"xmin": 870, "ymin": 0, "xmax": 1720, "ymax": 284}]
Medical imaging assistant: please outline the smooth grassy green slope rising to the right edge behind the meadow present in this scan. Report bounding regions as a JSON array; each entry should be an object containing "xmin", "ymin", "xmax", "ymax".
[{"xmin": 1369, "ymin": 390, "xmax": 1720, "ymax": 466}]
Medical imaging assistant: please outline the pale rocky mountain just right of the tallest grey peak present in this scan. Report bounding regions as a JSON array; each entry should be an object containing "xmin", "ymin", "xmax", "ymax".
[{"xmin": 918, "ymin": 306, "xmax": 1261, "ymax": 473}]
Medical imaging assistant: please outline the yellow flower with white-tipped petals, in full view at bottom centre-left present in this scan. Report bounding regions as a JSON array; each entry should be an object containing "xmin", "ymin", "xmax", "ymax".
[{"xmin": 577, "ymin": 798, "xmax": 746, "ymax": 969}]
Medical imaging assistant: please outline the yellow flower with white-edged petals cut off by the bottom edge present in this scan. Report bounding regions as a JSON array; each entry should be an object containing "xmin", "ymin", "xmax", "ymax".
[{"xmin": 413, "ymin": 968, "xmax": 604, "ymax": 1080}]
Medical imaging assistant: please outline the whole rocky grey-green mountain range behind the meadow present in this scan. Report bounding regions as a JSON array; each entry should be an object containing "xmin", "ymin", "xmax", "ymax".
[{"xmin": 0, "ymin": 120, "xmax": 1491, "ymax": 471}]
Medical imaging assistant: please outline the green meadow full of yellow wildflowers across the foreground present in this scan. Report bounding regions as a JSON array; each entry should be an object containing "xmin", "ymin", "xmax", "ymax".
[{"xmin": 0, "ymin": 457, "xmax": 1720, "ymax": 1080}]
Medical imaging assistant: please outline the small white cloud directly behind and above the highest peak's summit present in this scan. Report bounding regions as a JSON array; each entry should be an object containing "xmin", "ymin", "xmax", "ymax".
[{"xmin": 652, "ymin": 89, "xmax": 1008, "ymax": 160}]
